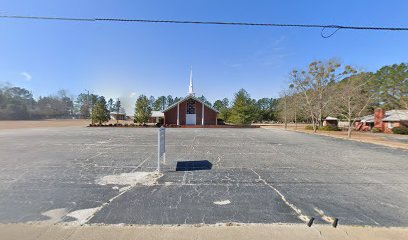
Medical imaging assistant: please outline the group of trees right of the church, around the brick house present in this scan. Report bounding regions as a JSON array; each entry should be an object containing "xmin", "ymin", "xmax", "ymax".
[{"xmin": 278, "ymin": 60, "xmax": 408, "ymax": 136}]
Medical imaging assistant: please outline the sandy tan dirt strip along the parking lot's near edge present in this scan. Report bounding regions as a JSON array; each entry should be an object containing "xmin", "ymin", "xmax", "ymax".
[{"xmin": 0, "ymin": 223, "xmax": 408, "ymax": 240}]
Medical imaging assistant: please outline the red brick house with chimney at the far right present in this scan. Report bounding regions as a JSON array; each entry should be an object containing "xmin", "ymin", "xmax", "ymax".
[{"xmin": 355, "ymin": 108, "xmax": 408, "ymax": 133}]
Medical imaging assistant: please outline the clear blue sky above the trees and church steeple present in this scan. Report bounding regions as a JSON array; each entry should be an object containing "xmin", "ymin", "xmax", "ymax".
[{"xmin": 0, "ymin": 0, "xmax": 408, "ymax": 113}]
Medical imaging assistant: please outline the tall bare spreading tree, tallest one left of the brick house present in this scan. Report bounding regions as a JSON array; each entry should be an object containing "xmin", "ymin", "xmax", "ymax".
[{"xmin": 290, "ymin": 60, "xmax": 356, "ymax": 132}]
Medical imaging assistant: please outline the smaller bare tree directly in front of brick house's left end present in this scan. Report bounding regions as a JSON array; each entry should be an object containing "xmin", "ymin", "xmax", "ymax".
[{"xmin": 332, "ymin": 73, "xmax": 375, "ymax": 138}]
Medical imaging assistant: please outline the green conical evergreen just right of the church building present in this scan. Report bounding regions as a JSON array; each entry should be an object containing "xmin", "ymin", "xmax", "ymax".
[{"xmin": 229, "ymin": 89, "xmax": 256, "ymax": 124}]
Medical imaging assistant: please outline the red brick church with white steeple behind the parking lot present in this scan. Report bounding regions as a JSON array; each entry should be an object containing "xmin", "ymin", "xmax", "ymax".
[{"xmin": 163, "ymin": 71, "xmax": 218, "ymax": 126}]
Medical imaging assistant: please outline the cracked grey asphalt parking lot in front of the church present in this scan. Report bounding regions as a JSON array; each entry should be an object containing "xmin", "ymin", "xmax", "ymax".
[{"xmin": 0, "ymin": 127, "xmax": 408, "ymax": 226}]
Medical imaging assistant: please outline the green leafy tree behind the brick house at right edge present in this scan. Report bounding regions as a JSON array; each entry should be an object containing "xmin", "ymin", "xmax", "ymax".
[{"xmin": 371, "ymin": 63, "xmax": 408, "ymax": 110}]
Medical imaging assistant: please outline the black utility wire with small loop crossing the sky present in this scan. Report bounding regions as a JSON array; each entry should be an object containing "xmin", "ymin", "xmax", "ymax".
[{"xmin": 0, "ymin": 15, "xmax": 408, "ymax": 38}]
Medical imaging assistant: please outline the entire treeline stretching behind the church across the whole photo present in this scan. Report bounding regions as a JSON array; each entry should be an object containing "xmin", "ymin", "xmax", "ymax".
[{"xmin": 0, "ymin": 60, "xmax": 408, "ymax": 127}]
